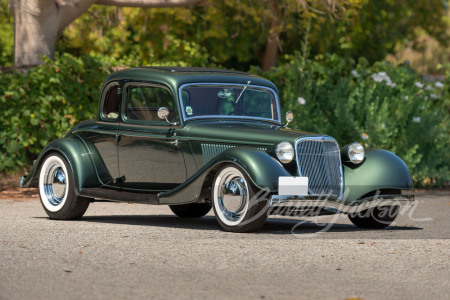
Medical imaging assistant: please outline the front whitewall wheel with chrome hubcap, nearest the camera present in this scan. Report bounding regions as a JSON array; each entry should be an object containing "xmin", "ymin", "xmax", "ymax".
[{"xmin": 211, "ymin": 165, "xmax": 268, "ymax": 232}]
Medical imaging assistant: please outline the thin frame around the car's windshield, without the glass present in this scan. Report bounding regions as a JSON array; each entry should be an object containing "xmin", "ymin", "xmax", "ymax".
[{"xmin": 178, "ymin": 82, "xmax": 282, "ymax": 125}]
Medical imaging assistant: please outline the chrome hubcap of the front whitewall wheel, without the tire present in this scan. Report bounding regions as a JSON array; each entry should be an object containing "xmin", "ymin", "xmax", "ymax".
[{"xmin": 218, "ymin": 171, "xmax": 248, "ymax": 222}]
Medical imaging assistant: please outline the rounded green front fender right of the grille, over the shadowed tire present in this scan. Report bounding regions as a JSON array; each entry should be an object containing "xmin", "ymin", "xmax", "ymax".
[{"xmin": 344, "ymin": 148, "xmax": 413, "ymax": 202}]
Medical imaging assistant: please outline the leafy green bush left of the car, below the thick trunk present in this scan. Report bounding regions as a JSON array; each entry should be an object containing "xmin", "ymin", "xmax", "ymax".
[{"xmin": 0, "ymin": 54, "xmax": 123, "ymax": 172}]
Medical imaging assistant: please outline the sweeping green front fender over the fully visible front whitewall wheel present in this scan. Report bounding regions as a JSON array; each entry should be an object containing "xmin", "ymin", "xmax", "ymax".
[{"xmin": 159, "ymin": 148, "xmax": 291, "ymax": 204}]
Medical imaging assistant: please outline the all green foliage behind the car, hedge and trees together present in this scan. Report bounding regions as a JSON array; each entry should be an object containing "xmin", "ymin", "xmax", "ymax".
[{"xmin": 0, "ymin": 0, "xmax": 450, "ymax": 186}]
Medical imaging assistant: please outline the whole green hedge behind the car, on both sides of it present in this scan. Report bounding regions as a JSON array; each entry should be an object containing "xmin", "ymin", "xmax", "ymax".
[{"xmin": 0, "ymin": 54, "xmax": 450, "ymax": 186}]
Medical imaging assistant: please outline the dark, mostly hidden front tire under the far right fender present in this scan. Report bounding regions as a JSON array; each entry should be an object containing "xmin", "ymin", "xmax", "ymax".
[{"xmin": 348, "ymin": 205, "xmax": 400, "ymax": 229}]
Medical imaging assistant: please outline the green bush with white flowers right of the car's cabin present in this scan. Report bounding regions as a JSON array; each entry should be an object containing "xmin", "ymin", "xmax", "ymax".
[{"xmin": 252, "ymin": 53, "xmax": 450, "ymax": 187}]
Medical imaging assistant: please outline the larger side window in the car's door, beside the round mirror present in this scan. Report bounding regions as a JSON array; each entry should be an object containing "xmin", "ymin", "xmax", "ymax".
[{"xmin": 126, "ymin": 86, "xmax": 174, "ymax": 121}]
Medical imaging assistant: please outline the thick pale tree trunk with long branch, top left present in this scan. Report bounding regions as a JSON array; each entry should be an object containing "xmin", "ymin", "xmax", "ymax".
[{"xmin": 10, "ymin": 0, "xmax": 201, "ymax": 67}]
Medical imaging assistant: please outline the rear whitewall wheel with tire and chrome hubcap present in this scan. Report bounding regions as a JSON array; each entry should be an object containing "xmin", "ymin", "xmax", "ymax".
[{"xmin": 39, "ymin": 153, "xmax": 90, "ymax": 220}]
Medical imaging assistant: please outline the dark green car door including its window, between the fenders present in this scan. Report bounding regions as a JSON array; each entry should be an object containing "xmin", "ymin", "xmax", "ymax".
[{"xmin": 118, "ymin": 83, "xmax": 186, "ymax": 192}]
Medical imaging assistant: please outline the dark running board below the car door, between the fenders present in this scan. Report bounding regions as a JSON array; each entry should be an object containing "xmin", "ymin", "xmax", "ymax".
[{"xmin": 80, "ymin": 188, "xmax": 159, "ymax": 205}]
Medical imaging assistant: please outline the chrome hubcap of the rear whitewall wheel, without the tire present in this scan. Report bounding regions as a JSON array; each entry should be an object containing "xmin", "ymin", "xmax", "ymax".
[{"xmin": 44, "ymin": 162, "xmax": 67, "ymax": 206}]
